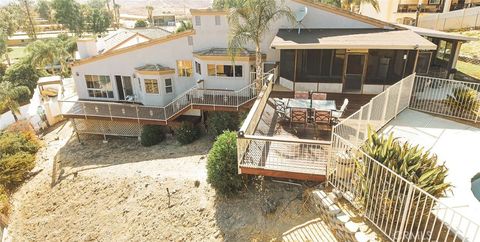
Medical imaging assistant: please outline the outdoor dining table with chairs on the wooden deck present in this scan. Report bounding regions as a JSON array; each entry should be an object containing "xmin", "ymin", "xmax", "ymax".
[{"xmin": 275, "ymin": 91, "xmax": 348, "ymax": 129}]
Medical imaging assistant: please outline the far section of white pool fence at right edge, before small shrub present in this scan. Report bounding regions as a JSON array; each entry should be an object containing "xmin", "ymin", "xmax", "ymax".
[{"xmin": 410, "ymin": 76, "xmax": 480, "ymax": 123}]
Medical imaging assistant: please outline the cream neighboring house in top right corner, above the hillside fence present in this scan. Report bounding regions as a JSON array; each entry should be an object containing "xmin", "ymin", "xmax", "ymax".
[{"xmin": 360, "ymin": 0, "xmax": 480, "ymax": 25}]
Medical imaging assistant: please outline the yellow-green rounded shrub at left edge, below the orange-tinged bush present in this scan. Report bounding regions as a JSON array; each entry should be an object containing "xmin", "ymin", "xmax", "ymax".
[{"xmin": 0, "ymin": 152, "xmax": 35, "ymax": 187}]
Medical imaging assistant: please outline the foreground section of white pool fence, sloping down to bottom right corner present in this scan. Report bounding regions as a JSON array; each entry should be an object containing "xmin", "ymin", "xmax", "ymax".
[{"xmin": 328, "ymin": 134, "xmax": 480, "ymax": 241}]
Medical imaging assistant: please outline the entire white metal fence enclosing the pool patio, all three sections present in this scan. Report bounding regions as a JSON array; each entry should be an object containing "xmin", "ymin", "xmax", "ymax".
[{"xmin": 327, "ymin": 75, "xmax": 480, "ymax": 241}]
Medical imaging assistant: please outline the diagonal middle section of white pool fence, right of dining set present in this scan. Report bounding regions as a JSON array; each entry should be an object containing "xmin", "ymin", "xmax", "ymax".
[{"xmin": 332, "ymin": 74, "xmax": 415, "ymax": 145}]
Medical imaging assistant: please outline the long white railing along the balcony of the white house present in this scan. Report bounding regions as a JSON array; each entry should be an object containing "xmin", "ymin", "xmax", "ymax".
[{"xmin": 59, "ymin": 76, "xmax": 266, "ymax": 122}]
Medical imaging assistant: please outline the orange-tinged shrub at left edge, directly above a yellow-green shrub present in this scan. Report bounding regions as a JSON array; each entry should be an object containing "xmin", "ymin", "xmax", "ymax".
[{"xmin": 0, "ymin": 132, "xmax": 40, "ymax": 158}]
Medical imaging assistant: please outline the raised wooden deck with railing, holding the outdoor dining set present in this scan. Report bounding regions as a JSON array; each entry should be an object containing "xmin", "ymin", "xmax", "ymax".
[{"xmin": 240, "ymin": 86, "xmax": 374, "ymax": 181}]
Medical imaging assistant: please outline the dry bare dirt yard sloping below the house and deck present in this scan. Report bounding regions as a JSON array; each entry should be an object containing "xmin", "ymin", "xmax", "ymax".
[{"xmin": 8, "ymin": 122, "xmax": 315, "ymax": 241}]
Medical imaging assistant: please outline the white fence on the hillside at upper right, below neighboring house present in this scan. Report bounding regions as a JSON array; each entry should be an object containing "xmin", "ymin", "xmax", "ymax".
[{"xmin": 418, "ymin": 7, "xmax": 480, "ymax": 30}]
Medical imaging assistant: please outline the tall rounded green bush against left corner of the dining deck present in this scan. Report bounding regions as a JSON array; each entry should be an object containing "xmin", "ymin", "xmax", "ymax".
[{"xmin": 207, "ymin": 131, "xmax": 243, "ymax": 194}]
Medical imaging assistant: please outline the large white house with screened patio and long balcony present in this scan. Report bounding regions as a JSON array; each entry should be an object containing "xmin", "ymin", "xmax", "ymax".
[{"xmin": 65, "ymin": 0, "xmax": 472, "ymax": 132}]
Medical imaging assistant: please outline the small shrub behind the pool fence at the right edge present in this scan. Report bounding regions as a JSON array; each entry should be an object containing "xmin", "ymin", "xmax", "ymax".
[{"xmin": 447, "ymin": 87, "xmax": 480, "ymax": 112}]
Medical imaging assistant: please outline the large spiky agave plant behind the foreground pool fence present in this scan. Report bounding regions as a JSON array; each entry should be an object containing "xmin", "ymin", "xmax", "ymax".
[{"xmin": 355, "ymin": 128, "xmax": 451, "ymax": 235}]
